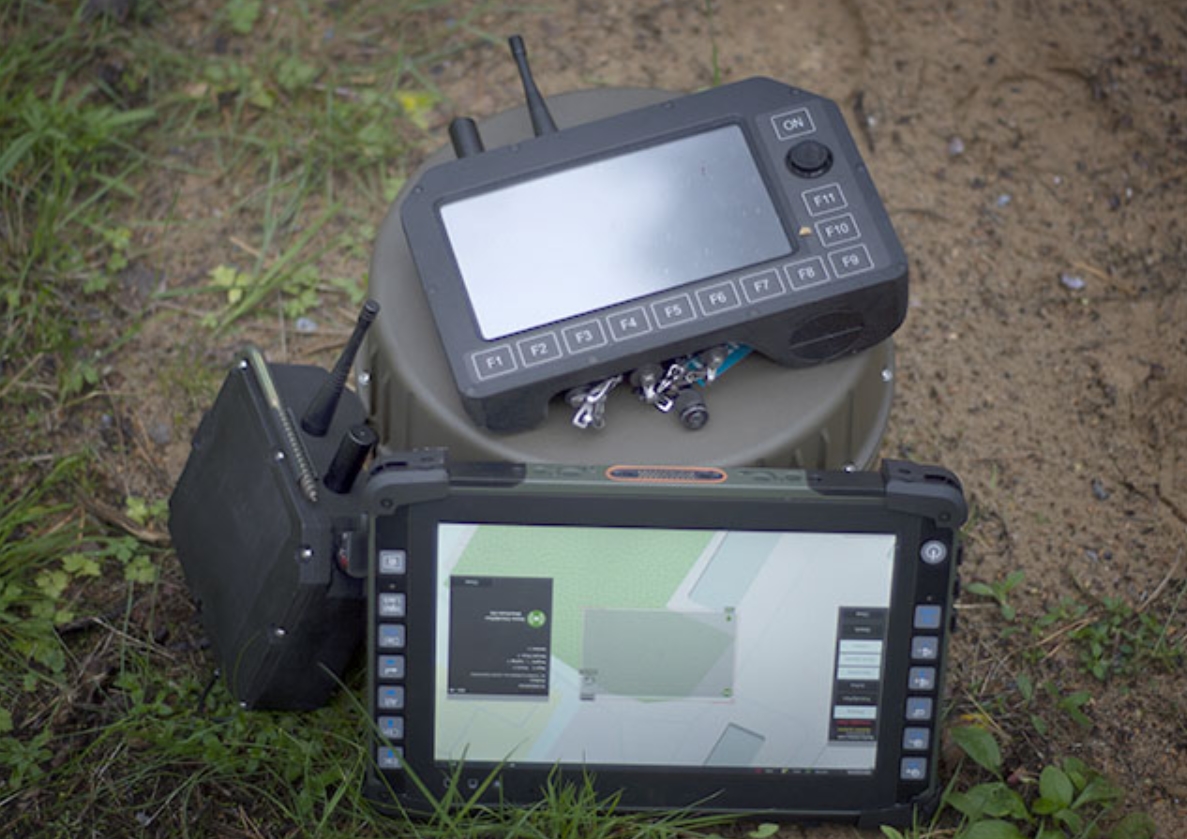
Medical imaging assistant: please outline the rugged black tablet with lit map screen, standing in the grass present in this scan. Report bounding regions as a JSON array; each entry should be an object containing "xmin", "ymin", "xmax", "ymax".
[{"xmin": 366, "ymin": 451, "xmax": 965, "ymax": 824}]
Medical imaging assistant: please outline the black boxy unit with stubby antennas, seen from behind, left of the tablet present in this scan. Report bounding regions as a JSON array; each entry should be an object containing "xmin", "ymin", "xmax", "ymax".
[{"xmin": 169, "ymin": 301, "xmax": 379, "ymax": 708}]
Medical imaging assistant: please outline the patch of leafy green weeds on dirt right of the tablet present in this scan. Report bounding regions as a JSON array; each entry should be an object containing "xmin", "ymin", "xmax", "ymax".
[{"xmin": 935, "ymin": 564, "xmax": 1185, "ymax": 839}]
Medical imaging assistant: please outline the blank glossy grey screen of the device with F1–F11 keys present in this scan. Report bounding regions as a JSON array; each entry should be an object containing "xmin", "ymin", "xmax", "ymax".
[{"xmin": 440, "ymin": 125, "xmax": 792, "ymax": 341}]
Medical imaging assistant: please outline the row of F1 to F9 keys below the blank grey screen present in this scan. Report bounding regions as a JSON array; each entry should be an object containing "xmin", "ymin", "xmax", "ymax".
[{"xmin": 470, "ymin": 239, "xmax": 874, "ymax": 381}]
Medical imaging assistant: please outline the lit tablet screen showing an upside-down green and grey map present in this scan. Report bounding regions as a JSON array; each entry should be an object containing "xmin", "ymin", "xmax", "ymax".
[{"xmin": 434, "ymin": 522, "xmax": 896, "ymax": 774}]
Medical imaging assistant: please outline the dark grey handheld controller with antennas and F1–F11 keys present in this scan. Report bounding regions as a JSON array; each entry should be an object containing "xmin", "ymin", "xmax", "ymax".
[{"xmin": 402, "ymin": 40, "xmax": 907, "ymax": 432}]
